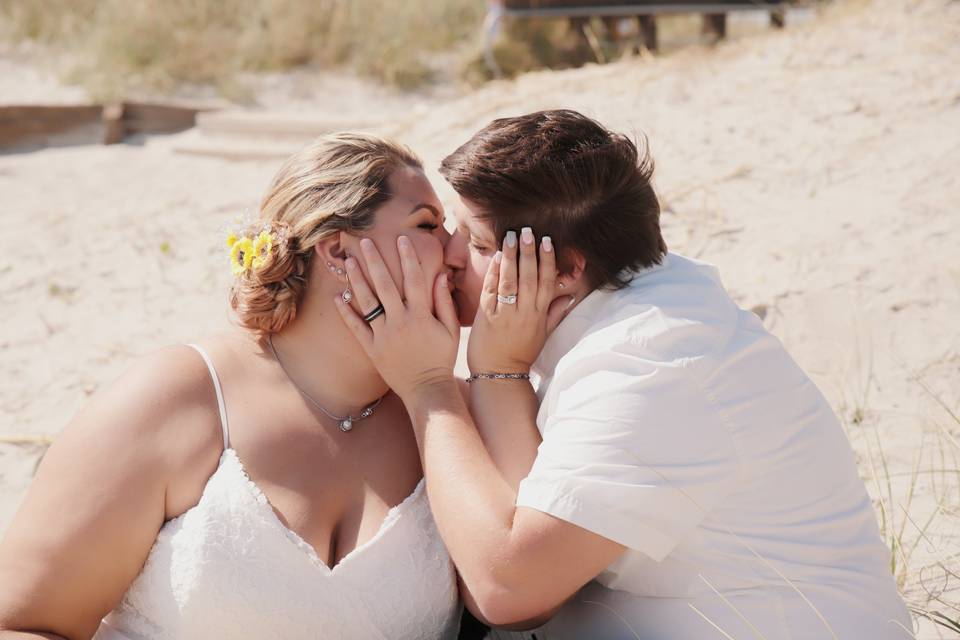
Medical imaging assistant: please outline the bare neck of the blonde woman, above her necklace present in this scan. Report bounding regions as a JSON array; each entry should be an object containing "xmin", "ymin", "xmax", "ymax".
[{"xmin": 266, "ymin": 287, "xmax": 390, "ymax": 416}]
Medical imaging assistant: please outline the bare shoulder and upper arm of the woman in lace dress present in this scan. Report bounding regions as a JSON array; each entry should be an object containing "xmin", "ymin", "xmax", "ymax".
[{"xmin": 0, "ymin": 346, "xmax": 223, "ymax": 637}]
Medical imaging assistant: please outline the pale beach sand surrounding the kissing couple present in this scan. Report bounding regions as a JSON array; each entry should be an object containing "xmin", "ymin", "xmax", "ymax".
[{"xmin": 0, "ymin": 0, "xmax": 960, "ymax": 638}]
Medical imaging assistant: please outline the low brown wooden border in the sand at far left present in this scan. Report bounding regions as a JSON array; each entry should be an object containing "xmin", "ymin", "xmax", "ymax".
[{"xmin": 0, "ymin": 102, "xmax": 210, "ymax": 150}]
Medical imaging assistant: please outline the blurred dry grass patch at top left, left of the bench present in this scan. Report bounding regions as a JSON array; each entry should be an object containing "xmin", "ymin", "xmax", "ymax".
[{"xmin": 0, "ymin": 0, "xmax": 484, "ymax": 97}]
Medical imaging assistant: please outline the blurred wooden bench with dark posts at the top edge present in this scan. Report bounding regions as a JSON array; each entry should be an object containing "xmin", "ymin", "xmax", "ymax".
[{"xmin": 484, "ymin": 0, "xmax": 789, "ymax": 76}]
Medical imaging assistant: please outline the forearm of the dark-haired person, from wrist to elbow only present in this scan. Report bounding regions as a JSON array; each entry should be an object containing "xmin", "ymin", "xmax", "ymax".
[{"xmin": 405, "ymin": 380, "xmax": 516, "ymax": 589}]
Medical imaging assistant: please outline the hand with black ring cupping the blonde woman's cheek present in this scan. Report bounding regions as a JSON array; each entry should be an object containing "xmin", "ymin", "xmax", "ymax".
[{"xmin": 335, "ymin": 236, "xmax": 460, "ymax": 399}]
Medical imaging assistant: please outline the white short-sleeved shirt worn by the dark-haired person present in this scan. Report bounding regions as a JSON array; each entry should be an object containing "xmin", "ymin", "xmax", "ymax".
[{"xmin": 517, "ymin": 253, "xmax": 910, "ymax": 640}]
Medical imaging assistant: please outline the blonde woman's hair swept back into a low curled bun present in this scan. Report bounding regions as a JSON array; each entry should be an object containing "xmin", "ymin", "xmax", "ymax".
[{"xmin": 230, "ymin": 133, "xmax": 423, "ymax": 337}]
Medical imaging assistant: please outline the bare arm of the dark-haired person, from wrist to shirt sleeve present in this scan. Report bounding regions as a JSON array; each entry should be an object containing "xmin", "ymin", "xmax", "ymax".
[{"xmin": 404, "ymin": 380, "xmax": 600, "ymax": 628}]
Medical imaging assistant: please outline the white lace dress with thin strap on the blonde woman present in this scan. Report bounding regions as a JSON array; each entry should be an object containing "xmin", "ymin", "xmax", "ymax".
[{"xmin": 95, "ymin": 344, "xmax": 461, "ymax": 640}]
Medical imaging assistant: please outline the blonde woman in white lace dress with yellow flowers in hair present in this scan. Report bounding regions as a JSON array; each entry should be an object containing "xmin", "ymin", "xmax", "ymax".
[{"xmin": 0, "ymin": 134, "xmax": 461, "ymax": 640}]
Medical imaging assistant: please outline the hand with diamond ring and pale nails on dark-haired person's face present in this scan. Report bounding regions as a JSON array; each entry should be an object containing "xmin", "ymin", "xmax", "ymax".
[{"xmin": 467, "ymin": 228, "xmax": 570, "ymax": 373}]
